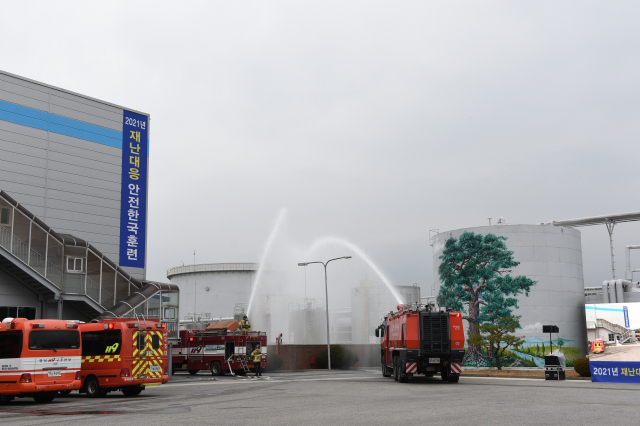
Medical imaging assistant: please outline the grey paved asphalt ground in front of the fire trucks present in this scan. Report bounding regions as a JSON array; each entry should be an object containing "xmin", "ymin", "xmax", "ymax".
[{"xmin": 0, "ymin": 370, "xmax": 640, "ymax": 426}]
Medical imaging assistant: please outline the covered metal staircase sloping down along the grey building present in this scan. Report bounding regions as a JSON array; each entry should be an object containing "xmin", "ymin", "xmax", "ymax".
[{"xmin": 0, "ymin": 190, "xmax": 177, "ymax": 326}]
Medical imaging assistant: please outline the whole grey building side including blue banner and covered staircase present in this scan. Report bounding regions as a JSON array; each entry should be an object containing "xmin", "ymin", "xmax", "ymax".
[{"xmin": 0, "ymin": 71, "xmax": 150, "ymax": 319}]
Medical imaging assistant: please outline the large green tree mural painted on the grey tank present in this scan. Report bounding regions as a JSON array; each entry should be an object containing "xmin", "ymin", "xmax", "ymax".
[{"xmin": 438, "ymin": 232, "xmax": 536, "ymax": 365}]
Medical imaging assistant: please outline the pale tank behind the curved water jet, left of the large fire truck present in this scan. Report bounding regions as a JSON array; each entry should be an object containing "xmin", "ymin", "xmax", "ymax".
[{"xmin": 351, "ymin": 280, "xmax": 420, "ymax": 343}]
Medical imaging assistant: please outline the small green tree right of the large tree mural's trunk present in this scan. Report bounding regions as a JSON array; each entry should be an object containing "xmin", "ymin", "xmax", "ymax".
[{"xmin": 467, "ymin": 317, "xmax": 524, "ymax": 370}]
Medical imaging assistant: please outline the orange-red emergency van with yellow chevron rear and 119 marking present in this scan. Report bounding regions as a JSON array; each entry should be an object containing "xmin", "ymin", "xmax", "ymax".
[{"xmin": 80, "ymin": 318, "xmax": 169, "ymax": 398}]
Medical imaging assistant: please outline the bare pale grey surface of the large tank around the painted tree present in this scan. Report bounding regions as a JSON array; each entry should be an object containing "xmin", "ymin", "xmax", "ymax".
[{"xmin": 433, "ymin": 224, "xmax": 586, "ymax": 364}]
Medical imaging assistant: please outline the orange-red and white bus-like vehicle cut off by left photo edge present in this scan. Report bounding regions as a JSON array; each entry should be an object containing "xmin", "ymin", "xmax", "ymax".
[{"xmin": 0, "ymin": 318, "xmax": 81, "ymax": 402}]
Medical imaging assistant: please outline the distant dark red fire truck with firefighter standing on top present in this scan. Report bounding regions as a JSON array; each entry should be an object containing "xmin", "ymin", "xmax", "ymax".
[{"xmin": 172, "ymin": 330, "xmax": 267, "ymax": 376}]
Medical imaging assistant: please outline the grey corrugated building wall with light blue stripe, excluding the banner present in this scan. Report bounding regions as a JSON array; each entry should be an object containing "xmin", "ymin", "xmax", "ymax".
[{"xmin": 0, "ymin": 72, "xmax": 146, "ymax": 279}]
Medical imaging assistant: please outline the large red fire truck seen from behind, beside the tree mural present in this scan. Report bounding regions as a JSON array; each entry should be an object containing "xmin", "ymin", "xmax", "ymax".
[{"xmin": 375, "ymin": 303, "xmax": 464, "ymax": 383}]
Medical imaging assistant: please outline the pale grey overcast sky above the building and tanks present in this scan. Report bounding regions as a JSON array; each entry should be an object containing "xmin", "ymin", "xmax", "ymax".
[{"xmin": 0, "ymin": 1, "xmax": 640, "ymax": 300}]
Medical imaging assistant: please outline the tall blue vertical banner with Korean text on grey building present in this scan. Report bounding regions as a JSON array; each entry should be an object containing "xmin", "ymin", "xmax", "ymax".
[{"xmin": 119, "ymin": 110, "xmax": 149, "ymax": 268}]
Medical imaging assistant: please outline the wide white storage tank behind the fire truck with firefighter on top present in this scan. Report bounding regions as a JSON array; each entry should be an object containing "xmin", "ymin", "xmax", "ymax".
[{"xmin": 167, "ymin": 263, "xmax": 258, "ymax": 320}]
